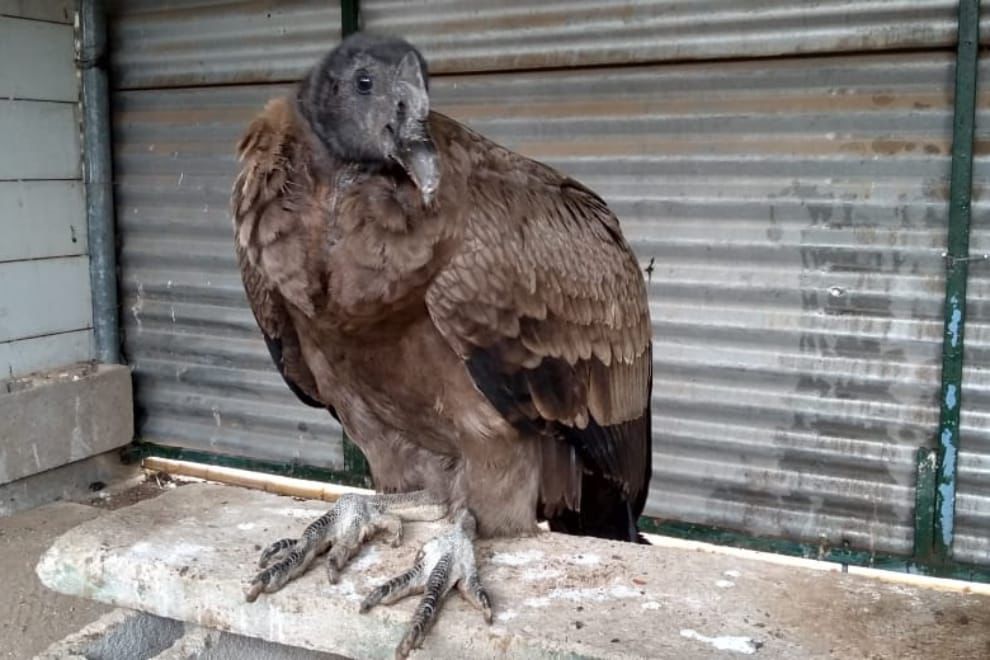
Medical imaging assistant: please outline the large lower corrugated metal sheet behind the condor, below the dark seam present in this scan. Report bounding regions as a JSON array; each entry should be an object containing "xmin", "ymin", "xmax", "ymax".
[{"xmin": 114, "ymin": 47, "xmax": 968, "ymax": 553}]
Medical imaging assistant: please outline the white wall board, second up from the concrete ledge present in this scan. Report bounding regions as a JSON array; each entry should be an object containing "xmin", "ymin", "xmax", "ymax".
[{"xmin": 0, "ymin": 256, "xmax": 93, "ymax": 341}]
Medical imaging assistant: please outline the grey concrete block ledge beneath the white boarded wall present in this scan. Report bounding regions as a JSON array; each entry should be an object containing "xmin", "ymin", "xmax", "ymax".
[{"xmin": 0, "ymin": 364, "xmax": 134, "ymax": 484}]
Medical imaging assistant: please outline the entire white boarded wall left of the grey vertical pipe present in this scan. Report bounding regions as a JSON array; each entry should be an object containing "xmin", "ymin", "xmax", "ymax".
[{"xmin": 0, "ymin": 0, "xmax": 93, "ymax": 380}]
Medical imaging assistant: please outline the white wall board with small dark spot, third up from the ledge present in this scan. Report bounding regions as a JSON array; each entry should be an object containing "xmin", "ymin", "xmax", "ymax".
[{"xmin": 0, "ymin": 181, "xmax": 87, "ymax": 262}]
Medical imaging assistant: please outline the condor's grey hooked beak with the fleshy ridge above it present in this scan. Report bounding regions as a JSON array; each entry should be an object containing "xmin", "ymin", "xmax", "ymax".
[{"xmin": 394, "ymin": 53, "xmax": 440, "ymax": 204}]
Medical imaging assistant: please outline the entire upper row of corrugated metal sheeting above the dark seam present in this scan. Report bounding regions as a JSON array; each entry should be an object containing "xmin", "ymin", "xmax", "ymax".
[{"xmin": 112, "ymin": 0, "xmax": 990, "ymax": 88}]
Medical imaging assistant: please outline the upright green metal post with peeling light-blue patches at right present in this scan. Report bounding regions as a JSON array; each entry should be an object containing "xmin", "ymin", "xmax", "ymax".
[{"xmin": 934, "ymin": 0, "xmax": 980, "ymax": 561}]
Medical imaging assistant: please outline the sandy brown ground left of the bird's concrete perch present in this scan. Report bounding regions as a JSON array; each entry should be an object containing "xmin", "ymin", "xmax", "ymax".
[{"xmin": 0, "ymin": 502, "xmax": 110, "ymax": 660}]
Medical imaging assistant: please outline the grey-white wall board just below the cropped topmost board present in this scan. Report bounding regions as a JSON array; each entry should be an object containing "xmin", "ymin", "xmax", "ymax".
[{"xmin": 0, "ymin": 16, "xmax": 79, "ymax": 103}]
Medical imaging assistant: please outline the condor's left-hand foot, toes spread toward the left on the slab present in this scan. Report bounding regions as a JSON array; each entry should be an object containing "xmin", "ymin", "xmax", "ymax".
[{"xmin": 245, "ymin": 491, "xmax": 447, "ymax": 603}]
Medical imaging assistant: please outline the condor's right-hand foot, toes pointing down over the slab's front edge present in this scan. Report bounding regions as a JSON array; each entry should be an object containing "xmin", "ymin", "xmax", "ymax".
[{"xmin": 361, "ymin": 510, "xmax": 492, "ymax": 658}]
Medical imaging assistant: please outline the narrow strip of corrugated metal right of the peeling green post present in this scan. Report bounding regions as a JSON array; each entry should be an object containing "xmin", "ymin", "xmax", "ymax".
[{"xmin": 952, "ymin": 56, "xmax": 990, "ymax": 564}]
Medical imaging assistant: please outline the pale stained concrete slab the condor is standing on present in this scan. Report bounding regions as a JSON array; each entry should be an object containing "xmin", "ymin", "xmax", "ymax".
[{"xmin": 37, "ymin": 485, "xmax": 990, "ymax": 660}]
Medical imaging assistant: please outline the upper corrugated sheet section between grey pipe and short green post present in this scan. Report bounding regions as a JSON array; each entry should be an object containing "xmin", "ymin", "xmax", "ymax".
[{"xmin": 110, "ymin": 0, "xmax": 340, "ymax": 88}]
